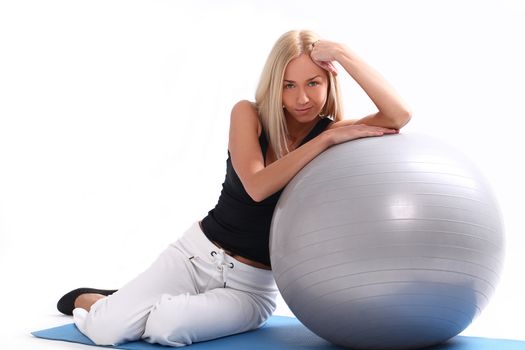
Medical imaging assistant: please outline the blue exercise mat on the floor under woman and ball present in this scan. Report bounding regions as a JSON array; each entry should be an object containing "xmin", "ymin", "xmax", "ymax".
[{"xmin": 31, "ymin": 316, "xmax": 525, "ymax": 350}]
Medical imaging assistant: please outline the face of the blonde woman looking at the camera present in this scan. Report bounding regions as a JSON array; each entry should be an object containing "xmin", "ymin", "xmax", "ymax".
[{"xmin": 283, "ymin": 54, "xmax": 328, "ymax": 123}]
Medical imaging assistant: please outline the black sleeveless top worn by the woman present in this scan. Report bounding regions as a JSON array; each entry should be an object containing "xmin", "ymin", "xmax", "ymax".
[{"xmin": 202, "ymin": 118, "xmax": 332, "ymax": 266}]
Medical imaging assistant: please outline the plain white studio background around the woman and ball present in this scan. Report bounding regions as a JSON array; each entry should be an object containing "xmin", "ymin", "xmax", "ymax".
[{"xmin": 0, "ymin": 0, "xmax": 525, "ymax": 349}]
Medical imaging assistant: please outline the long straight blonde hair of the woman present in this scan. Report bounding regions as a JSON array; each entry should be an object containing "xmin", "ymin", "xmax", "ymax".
[{"xmin": 255, "ymin": 30, "xmax": 343, "ymax": 159}]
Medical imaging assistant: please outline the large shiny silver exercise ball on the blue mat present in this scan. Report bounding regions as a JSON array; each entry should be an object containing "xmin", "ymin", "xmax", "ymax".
[{"xmin": 270, "ymin": 133, "xmax": 504, "ymax": 349}]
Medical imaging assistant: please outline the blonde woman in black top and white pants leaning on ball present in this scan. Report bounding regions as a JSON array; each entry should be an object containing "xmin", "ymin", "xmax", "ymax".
[{"xmin": 58, "ymin": 31, "xmax": 410, "ymax": 346}]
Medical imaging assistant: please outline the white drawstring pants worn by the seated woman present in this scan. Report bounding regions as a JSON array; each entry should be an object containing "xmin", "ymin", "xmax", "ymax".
[{"xmin": 73, "ymin": 223, "xmax": 278, "ymax": 346}]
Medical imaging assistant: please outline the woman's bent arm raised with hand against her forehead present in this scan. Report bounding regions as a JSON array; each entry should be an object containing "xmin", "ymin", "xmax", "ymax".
[{"xmin": 311, "ymin": 40, "xmax": 411, "ymax": 129}]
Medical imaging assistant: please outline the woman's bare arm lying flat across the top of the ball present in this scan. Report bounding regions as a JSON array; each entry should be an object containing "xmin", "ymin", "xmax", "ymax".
[{"xmin": 228, "ymin": 101, "xmax": 397, "ymax": 202}]
